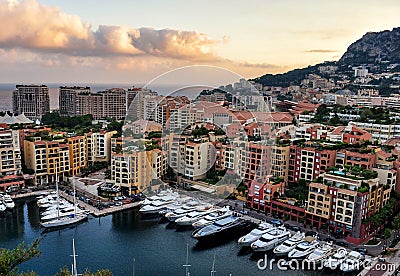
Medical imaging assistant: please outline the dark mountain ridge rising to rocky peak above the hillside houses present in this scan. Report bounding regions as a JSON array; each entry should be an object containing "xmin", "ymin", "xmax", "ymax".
[{"xmin": 252, "ymin": 27, "xmax": 400, "ymax": 87}]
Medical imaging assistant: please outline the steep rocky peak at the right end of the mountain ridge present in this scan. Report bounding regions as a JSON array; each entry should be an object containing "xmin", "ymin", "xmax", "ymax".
[{"xmin": 338, "ymin": 28, "xmax": 400, "ymax": 65}]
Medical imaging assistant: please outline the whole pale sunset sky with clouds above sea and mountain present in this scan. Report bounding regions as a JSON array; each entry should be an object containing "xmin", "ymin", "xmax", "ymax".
[{"xmin": 0, "ymin": 0, "xmax": 400, "ymax": 84}]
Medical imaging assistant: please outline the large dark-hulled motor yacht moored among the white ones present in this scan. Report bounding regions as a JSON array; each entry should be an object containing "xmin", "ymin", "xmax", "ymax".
[{"xmin": 192, "ymin": 216, "xmax": 246, "ymax": 241}]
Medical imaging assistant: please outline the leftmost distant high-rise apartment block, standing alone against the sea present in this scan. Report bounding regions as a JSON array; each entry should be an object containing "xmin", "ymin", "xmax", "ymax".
[{"xmin": 13, "ymin": 85, "xmax": 50, "ymax": 120}]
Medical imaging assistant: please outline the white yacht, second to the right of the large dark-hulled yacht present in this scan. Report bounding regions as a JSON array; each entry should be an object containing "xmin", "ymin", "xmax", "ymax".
[{"xmin": 251, "ymin": 226, "xmax": 291, "ymax": 251}]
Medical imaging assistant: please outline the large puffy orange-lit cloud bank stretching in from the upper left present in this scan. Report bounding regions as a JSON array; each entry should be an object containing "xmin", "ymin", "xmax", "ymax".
[{"xmin": 0, "ymin": 0, "xmax": 219, "ymax": 60}]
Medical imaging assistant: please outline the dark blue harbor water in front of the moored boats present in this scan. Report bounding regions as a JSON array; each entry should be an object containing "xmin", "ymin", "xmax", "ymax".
[{"xmin": 0, "ymin": 199, "xmax": 344, "ymax": 276}]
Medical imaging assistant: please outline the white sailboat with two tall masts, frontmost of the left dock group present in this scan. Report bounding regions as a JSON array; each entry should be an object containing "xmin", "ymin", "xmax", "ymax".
[{"xmin": 40, "ymin": 175, "xmax": 88, "ymax": 228}]
